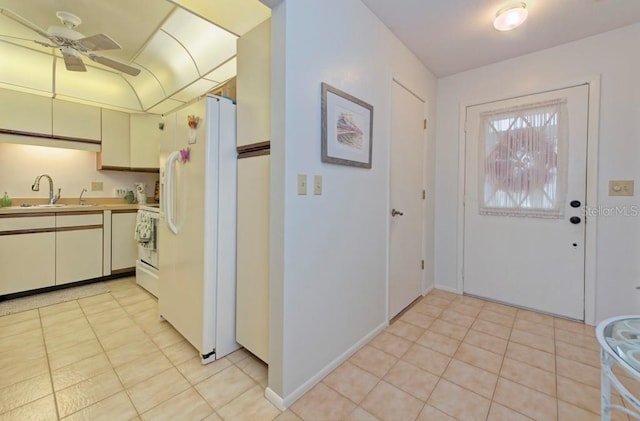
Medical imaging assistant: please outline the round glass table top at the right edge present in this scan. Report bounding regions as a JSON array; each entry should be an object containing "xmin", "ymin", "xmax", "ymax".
[{"xmin": 602, "ymin": 317, "xmax": 640, "ymax": 372}]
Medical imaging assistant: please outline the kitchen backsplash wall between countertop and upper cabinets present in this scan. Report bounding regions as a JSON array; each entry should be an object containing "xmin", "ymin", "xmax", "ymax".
[{"xmin": 0, "ymin": 143, "xmax": 158, "ymax": 201}]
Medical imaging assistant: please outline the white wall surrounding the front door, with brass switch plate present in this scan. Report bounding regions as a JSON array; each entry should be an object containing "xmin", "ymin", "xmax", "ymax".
[{"xmin": 435, "ymin": 24, "xmax": 640, "ymax": 320}]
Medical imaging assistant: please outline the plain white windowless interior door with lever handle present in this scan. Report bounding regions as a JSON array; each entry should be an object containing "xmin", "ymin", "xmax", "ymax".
[{"xmin": 389, "ymin": 81, "xmax": 425, "ymax": 318}]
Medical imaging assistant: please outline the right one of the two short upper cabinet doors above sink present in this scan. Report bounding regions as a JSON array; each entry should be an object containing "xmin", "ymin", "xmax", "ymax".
[{"xmin": 53, "ymin": 99, "xmax": 101, "ymax": 142}]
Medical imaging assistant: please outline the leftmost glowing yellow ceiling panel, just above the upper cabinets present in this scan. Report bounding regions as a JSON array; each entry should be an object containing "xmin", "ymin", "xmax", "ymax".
[{"xmin": 0, "ymin": 42, "xmax": 53, "ymax": 92}]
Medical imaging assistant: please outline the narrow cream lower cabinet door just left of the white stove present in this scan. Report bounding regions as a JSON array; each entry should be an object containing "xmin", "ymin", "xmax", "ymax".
[{"xmin": 111, "ymin": 212, "xmax": 138, "ymax": 273}]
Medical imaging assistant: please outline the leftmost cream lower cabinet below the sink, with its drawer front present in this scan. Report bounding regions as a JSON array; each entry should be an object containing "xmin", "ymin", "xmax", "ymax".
[{"xmin": 0, "ymin": 215, "xmax": 56, "ymax": 295}]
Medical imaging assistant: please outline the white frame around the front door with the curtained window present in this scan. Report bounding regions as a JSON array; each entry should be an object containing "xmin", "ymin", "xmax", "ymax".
[{"xmin": 456, "ymin": 75, "xmax": 600, "ymax": 326}]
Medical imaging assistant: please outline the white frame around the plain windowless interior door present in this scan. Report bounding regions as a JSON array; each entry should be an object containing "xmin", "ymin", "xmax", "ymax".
[{"xmin": 385, "ymin": 75, "xmax": 433, "ymax": 324}]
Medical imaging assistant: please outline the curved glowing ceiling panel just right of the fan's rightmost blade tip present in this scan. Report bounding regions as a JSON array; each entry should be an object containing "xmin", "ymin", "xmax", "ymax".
[{"xmin": 134, "ymin": 31, "xmax": 200, "ymax": 95}]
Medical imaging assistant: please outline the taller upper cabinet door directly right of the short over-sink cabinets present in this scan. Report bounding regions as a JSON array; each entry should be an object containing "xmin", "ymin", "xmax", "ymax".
[{"xmin": 99, "ymin": 109, "xmax": 131, "ymax": 168}]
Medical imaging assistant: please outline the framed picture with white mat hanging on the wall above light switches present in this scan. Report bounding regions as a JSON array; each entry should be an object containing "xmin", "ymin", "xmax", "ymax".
[{"xmin": 322, "ymin": 83, "xmax": 373, "ymax": 168}]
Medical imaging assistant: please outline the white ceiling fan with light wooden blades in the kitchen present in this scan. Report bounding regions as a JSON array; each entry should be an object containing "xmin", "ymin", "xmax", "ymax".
[{"xmin": 0, "ymin": 9, "xmax": 140, "ymax": 76}]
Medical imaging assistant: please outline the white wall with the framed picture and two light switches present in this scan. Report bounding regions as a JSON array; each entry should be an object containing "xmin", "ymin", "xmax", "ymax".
[{"xmin": 269, "ymin": 0, "xmax": 436, "ymax": 405}]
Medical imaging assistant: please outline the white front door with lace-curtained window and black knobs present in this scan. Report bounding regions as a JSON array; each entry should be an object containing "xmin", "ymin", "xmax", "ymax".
[{"xmin": 463, "ymin": 85, "xmax": 589, "ymax": 320}]
